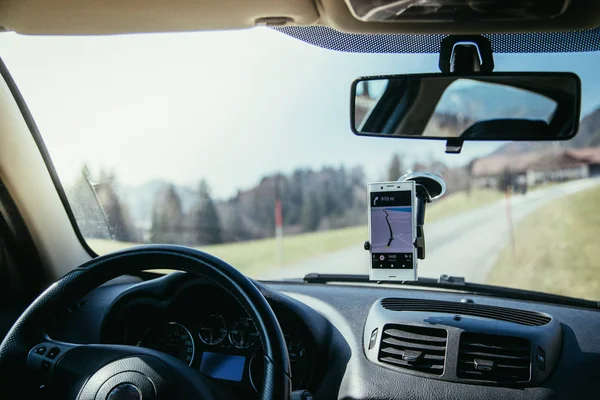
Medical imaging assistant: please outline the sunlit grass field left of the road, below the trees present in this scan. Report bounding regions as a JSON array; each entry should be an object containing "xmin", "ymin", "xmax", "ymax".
[{"xmin": 87, "ymin": 190, "xmax": 502, "ymax": 276}]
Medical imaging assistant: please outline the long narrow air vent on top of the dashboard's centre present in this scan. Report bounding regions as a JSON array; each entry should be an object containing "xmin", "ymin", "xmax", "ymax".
[{"xmin": 381, "ymin": 298, "xmax": 551, "ymax": 326}]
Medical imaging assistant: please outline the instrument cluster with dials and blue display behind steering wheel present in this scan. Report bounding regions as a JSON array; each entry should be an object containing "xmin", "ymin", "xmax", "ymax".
[{"xmin": 125, "ymin": 293, "xmax": 312, "ymax": 391}]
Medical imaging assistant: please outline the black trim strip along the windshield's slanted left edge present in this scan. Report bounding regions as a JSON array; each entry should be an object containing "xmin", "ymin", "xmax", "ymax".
[{"xmin": 0, "ymin": 57, "xmax": 98, "ymax": 258}]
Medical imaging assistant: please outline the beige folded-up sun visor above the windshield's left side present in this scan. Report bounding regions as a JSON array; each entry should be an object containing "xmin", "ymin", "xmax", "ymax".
[{"xmin": 0, "ymin": 0, "xmax": 319, "ymax": 35}]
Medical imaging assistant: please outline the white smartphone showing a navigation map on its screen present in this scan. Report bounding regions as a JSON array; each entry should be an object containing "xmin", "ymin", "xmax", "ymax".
[{"xmin": 367, "ymin": 181, "xmax": 417, "ymax": 281}]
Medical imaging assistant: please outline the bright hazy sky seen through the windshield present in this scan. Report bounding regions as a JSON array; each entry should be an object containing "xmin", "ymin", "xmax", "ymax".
[{"xmin": 0, "ymin": 28, "xmax": 600, "ymax": 198}]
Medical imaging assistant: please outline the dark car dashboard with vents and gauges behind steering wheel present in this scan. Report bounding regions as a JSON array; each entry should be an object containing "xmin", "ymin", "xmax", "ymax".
[{"xmin": 49, "ymin": 273, "xmax": 600, "ymax": 399}]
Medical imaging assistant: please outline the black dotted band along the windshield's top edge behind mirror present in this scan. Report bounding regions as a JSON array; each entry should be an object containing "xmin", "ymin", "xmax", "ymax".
[{"xmin": 273, "ymin": 26, "xmax": 600, "ymax": 53}]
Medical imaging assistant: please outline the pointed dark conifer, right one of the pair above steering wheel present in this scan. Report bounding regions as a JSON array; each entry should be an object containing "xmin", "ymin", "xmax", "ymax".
[{"xmin": 189, "ymin": 180, "xmax": 222, "ymax": 245}]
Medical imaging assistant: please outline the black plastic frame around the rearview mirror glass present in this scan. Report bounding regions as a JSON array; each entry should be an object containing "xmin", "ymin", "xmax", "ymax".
[{"xmin": 350, "ymin": 72, "xmax": 581, "ymax": 142}]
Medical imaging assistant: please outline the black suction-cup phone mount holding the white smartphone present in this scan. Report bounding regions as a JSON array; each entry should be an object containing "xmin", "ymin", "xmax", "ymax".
[{"xmin": 364, "ymin": 172, "xmax": 446, "ymax": 260}]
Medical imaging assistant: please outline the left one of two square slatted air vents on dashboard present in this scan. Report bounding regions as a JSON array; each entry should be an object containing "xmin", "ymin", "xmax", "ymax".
[{"xmin": 378, "ymin": 324, "xmax": 447, "ymax": 375}]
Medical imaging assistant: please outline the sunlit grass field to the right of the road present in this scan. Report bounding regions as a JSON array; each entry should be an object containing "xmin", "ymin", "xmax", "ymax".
[{"xmin": 487, "ymin": 184, "xmax": 600, "ymax": 300}]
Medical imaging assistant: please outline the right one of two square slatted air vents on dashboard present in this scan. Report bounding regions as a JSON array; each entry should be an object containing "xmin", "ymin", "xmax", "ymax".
[{"xmin": 456, "ymin": 332, "xmax": 531, "ymax": 383}]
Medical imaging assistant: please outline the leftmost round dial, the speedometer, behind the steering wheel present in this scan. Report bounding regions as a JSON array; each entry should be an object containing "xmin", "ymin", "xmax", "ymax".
[{"xmin": 137, "ymin": 322, "xmax": 195, "ymax": 365}]
